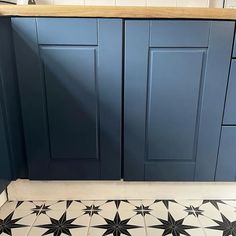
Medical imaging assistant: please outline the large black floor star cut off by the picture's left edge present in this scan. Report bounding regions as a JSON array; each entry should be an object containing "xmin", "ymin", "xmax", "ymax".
[{"xmin": 0, "ymin": 211, "xmax": 27, "ymax": 235}]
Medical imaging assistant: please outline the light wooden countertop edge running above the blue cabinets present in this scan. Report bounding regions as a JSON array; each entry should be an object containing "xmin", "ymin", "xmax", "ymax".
[{"xmin": 0, "ymin": 5, "xmax": 236, "ymax": 20}]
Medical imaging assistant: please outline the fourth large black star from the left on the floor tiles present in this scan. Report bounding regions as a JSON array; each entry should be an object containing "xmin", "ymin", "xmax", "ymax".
[{"xmin": 149, "ymin": 212, "xmax": 198, "ymax": 236}]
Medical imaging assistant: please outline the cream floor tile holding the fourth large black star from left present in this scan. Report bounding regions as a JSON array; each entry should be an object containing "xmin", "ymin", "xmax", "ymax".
[{"xmin": 142, "ymin": 200, "xmax": 204, "ymax": 236}]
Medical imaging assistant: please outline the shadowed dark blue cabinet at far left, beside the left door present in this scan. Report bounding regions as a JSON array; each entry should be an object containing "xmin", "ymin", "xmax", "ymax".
[{"xmin": 0, "ymin": 17, "xmax": 27, "ymax": 193}]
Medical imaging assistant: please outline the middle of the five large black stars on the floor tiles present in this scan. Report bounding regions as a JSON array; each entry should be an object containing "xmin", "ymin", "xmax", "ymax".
[{"xmin": 93, "ymin": 212, "xmax": 141, "ymax": 236}]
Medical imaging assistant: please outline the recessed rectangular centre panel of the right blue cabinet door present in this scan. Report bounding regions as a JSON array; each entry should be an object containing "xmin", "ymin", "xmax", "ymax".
[{"xmin": 147, "ymin": 48, "xmax": 205, "ymax": 160}]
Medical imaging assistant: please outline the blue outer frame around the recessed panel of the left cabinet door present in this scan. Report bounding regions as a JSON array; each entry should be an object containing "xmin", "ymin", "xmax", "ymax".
[{"xmin": 12, "ymin": 17, "xmax": 122, "ymax": 179}]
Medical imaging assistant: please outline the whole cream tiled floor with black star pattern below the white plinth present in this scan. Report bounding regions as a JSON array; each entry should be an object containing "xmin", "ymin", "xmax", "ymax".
[{"xmin": 0, "ymin": 200, "xmax": 236, "ymax": 236}]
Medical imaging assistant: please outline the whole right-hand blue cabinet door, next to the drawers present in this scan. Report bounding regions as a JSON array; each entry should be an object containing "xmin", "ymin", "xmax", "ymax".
[{"xmin": 124, "ymin": 20, "xmax": 234, "ymax": 180}]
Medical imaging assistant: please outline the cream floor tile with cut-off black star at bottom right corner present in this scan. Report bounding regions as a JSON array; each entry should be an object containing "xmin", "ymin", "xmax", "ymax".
[{"xmin": 194, "ymin": 200, "xmax": 236, "ymax": 236}]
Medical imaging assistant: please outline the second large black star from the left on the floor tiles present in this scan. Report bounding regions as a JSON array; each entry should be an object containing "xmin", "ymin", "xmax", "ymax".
[{"xmin": 37, "ymin": 212, "xmax": 85, "ymax": 236}]
